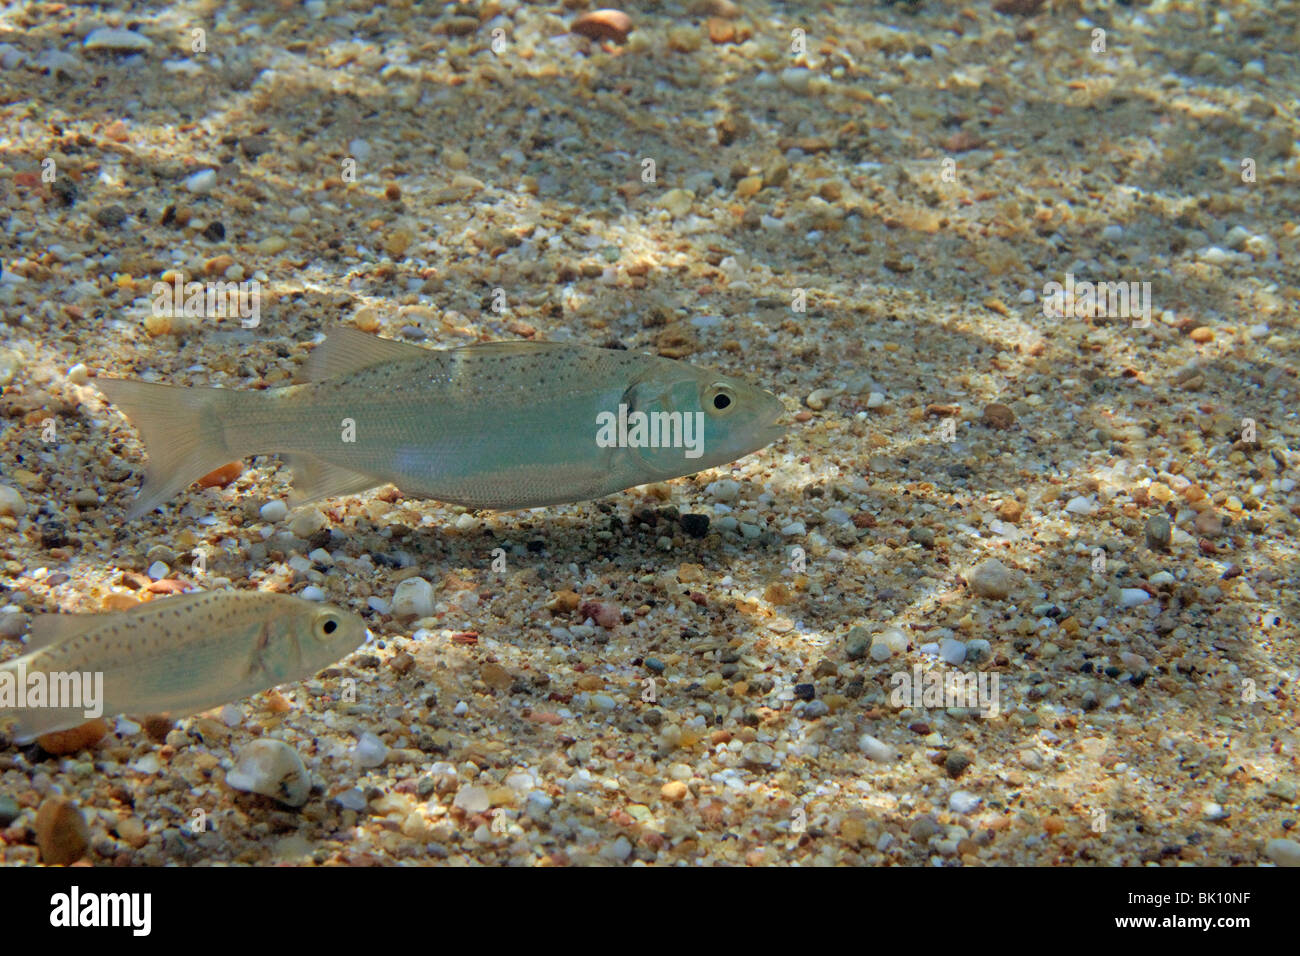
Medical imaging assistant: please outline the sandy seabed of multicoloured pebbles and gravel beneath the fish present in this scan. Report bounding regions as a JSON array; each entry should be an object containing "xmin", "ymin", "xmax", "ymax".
[{"xmin": 0, "ymin": 0, "xmax": 1300, "ymax": 865}]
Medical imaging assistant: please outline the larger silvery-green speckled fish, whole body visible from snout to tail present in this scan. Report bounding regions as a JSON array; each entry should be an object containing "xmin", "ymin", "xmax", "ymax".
[{"xmin": 96, "ymin": 328, "xmax": 785, "ymax": 518}]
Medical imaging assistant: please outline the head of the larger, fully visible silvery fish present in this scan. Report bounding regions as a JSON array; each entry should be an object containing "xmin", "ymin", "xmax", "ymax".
[{"xmin": 627, "ymin": 362, "xmax": 785, "ymax": 479}]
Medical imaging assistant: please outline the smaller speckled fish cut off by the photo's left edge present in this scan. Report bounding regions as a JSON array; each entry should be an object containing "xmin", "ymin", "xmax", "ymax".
[{"xmin": 0, "ymin": 591, "xmax": 365, "ymax": 744}]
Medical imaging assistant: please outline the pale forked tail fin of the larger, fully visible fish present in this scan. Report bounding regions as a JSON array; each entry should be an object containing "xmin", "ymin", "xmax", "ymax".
[{"xmin": 95, "ymin": 378, "xmax": 257, "ymax": 520}]
